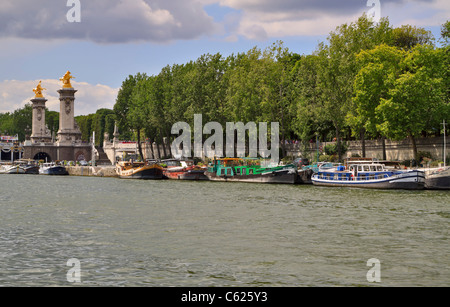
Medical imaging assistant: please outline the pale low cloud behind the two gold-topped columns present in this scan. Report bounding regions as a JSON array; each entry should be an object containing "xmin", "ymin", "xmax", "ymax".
[{"xmin": 0, "ymin": 79, "xmax": 119, "ymax": 116}]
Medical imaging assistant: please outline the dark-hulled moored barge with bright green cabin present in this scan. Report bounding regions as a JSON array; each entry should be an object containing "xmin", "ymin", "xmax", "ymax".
[{"xmin": 205, "ymin": 158, "xmax": 298, "ymax": 184}]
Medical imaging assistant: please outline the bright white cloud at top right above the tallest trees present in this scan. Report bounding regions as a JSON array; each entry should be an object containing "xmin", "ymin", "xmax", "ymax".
[{"xmin": 213, "ymin": 0, "xmax": 450, "ymax": 40}]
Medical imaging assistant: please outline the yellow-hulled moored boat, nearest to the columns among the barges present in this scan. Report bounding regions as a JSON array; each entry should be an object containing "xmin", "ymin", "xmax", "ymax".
[{"xmin": 116, "ymin": 161, "xmax": 163, "ymax": 179}]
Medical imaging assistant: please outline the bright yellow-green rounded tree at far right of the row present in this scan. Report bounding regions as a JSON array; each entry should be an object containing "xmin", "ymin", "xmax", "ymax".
[{"xmin": 376, "ymin": 45, "xmax": 450, "ymax": 161}]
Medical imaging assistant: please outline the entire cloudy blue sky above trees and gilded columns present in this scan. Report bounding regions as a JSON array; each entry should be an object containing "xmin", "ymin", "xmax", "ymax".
[{"xmin": 0, "ymin": 0, "xmax": 450, "ymax": 115}]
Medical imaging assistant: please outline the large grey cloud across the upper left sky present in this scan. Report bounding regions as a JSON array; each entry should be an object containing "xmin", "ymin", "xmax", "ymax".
[{"xmin": 0, "ymin": 0, "xmax": 218, "ymax": 43}]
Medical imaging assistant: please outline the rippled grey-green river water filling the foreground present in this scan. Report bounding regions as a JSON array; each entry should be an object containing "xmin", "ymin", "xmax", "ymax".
[{"xmin": 0, "ymin": 175, "xmax": 450, "ymax": 287}]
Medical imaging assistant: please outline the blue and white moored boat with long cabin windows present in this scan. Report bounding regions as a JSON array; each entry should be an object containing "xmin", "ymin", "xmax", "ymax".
[{"xmin": 312, "ymin": 163, "xmax": 425, "ymax": 190}]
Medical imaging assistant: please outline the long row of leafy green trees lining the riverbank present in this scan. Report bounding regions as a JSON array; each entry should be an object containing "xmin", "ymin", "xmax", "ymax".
[{"xmin": 114, "ymin": 15, "xmax": 450, "ymax": 158}]
